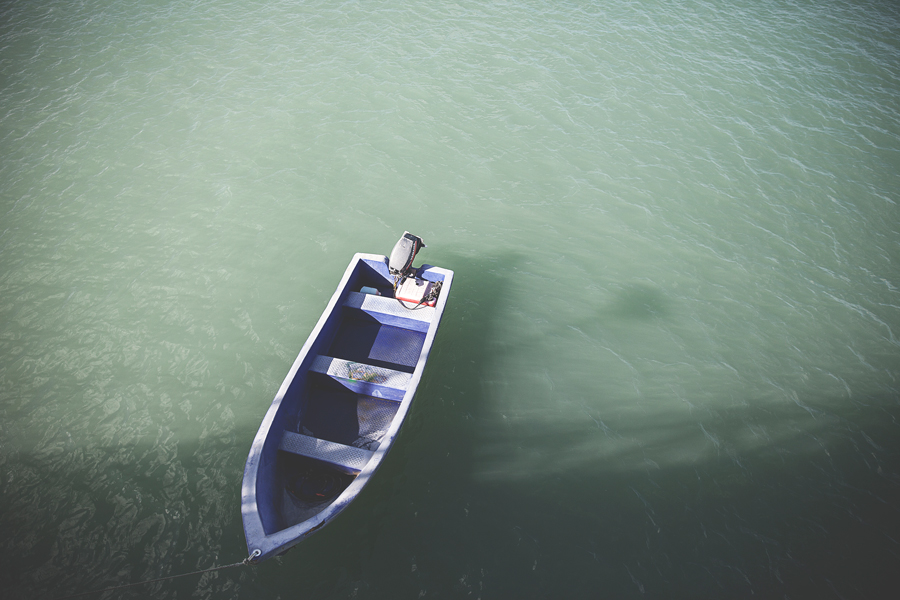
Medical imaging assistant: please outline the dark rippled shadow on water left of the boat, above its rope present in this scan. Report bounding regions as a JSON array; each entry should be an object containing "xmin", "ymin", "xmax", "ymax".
[{"xmin": 0, "ymin": 432, "xmax": 252, "ymax": 598}]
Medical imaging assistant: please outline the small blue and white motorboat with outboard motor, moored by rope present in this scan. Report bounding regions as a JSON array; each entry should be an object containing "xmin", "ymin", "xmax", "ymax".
[{"xmin": 241, "ymin": 232, "xmax": 453, "ymax": 562}]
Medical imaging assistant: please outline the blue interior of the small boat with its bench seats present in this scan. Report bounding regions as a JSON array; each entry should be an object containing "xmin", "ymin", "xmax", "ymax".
[{"xmin": 260, "ymin": 259, "xmax": 443, "ymax": 533}]
